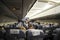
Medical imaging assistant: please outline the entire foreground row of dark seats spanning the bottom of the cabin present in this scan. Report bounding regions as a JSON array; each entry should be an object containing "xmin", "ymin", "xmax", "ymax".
[{"xmin": 0, "ymin": 23, "xmax": 60, "ymax": 40}]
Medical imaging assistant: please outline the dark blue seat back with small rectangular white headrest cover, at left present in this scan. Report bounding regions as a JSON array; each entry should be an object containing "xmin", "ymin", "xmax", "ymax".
[{"xmin": 6, "ymin": 29, "xmax": 25, "ymax": 40}]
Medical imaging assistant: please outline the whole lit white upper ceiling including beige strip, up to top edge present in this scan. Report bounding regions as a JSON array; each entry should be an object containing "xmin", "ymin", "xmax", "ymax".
[{"xmin": 25, "ymin": 0, "xmax": 60, "ymax": 18}]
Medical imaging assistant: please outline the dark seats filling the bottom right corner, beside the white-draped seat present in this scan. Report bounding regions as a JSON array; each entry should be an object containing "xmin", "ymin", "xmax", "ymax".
[{"xmin": 43, "ymin": 28, "xmax": 60, "ymax": 40}]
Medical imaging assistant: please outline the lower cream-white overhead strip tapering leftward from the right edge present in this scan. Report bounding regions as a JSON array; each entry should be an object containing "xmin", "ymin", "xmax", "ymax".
[{"xmin": 30, "ymin": 6, "xmax": 60, "ymax": 19}]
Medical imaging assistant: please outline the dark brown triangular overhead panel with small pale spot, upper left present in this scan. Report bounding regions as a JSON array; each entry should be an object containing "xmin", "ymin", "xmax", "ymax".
[{"xmin": 1, "ymin": 0, "xmax": 22, "ymax": 18}]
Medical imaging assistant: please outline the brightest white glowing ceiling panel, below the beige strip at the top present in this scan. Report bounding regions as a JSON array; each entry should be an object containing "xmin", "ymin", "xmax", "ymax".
[{"xmin": 26, "ymin": 1, "xmax": 53, "ymax": 17}]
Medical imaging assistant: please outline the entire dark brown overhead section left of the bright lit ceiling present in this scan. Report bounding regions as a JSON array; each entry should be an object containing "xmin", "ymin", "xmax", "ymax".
[{"xmin": 0, "ymin": 0, "xmax": 36, "ymax": 21}]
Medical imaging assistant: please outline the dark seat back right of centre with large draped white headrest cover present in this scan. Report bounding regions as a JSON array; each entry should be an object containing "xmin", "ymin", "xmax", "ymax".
[{"xmin": 27, "ymin": 29, "xmax": 43, "ymax": 40}]
